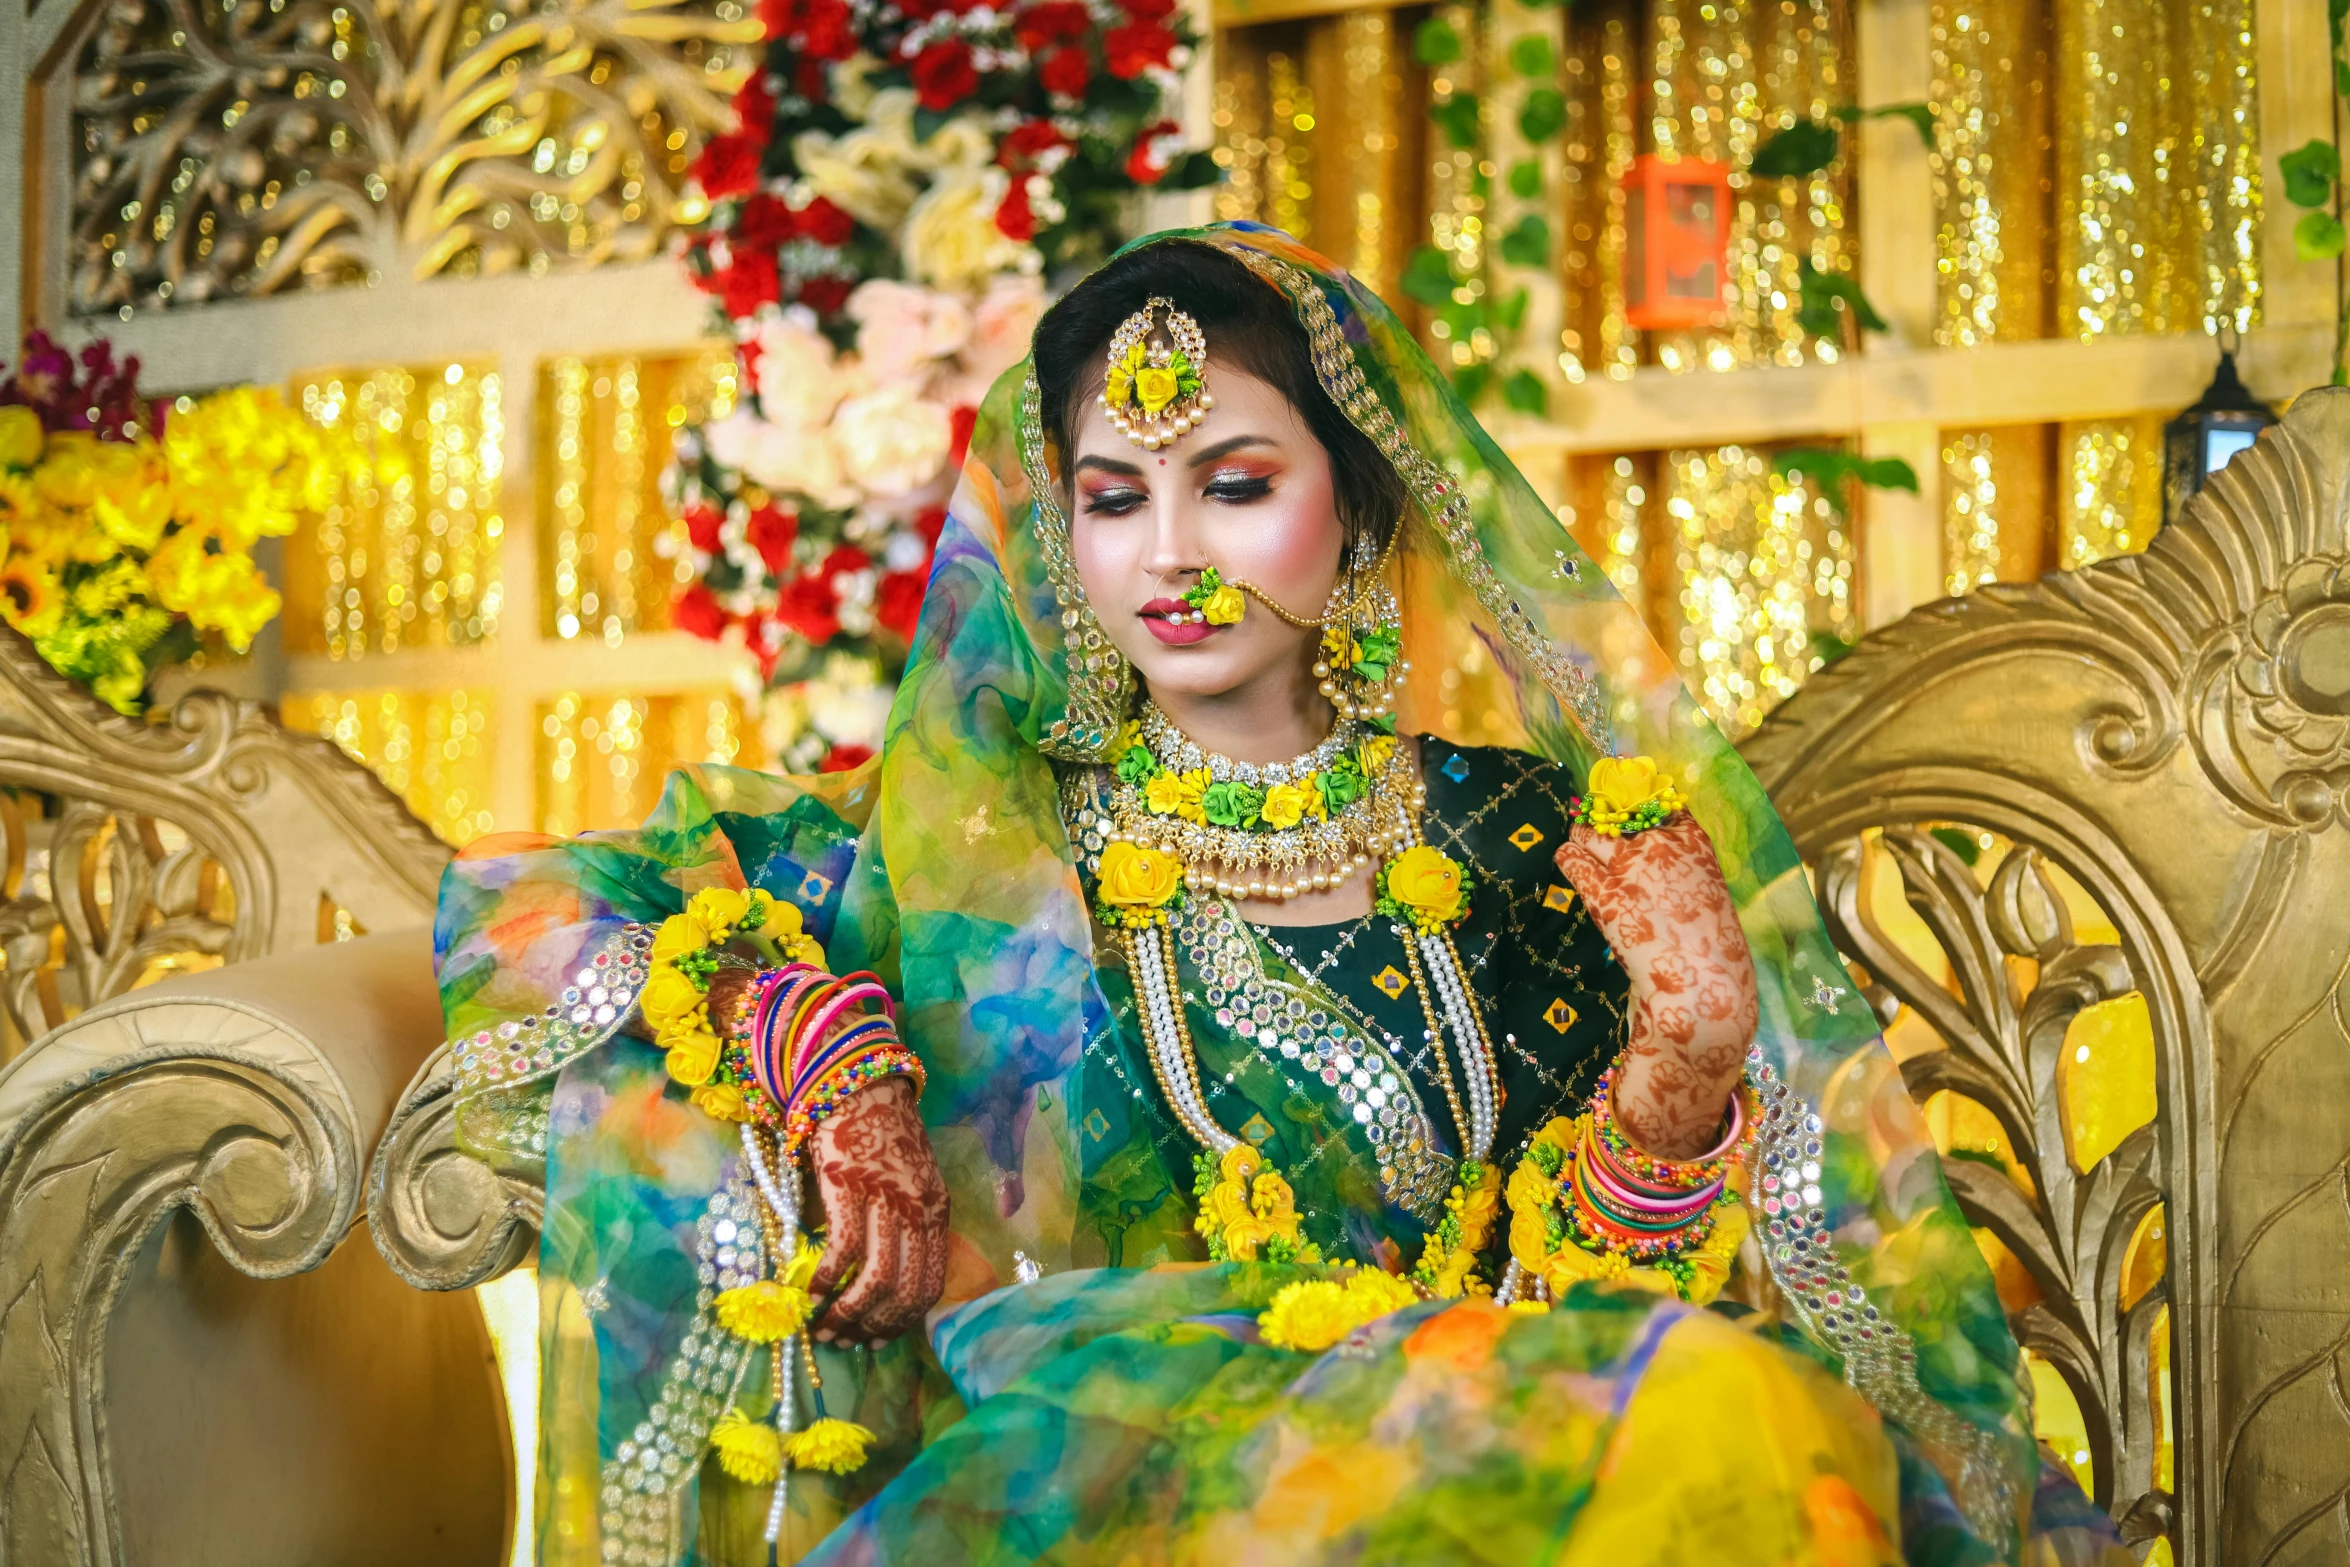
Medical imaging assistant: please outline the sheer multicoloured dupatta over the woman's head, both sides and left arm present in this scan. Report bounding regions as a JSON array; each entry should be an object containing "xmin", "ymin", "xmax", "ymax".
[{"xmin": 437, "ymin": 226, "xmax": 2035, "ymax": 1562}]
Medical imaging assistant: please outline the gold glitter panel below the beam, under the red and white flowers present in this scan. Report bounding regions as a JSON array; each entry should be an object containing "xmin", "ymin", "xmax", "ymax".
[{"xmin": 536, "ymin": 691, "xmax": 759, "ymax": 834}]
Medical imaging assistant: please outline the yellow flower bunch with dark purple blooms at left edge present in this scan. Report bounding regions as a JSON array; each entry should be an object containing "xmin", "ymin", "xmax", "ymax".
[{"xmin": 0, "ymin": 331, "xmax": 360, "ymax": 714}]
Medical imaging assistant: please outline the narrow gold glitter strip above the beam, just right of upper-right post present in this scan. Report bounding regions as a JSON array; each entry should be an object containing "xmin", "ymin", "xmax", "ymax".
[{"xmin": 1932, "ymin": 0, "xmax": 2056, "ymax": 348}]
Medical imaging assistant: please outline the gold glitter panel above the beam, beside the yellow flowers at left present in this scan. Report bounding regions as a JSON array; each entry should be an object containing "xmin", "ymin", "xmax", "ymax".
[{"xmin": 284, "ymin": 364, "xmax": 505, "ymax": 660}]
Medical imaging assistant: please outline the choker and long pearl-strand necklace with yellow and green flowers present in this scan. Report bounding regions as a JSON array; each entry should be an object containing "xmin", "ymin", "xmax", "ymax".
[{"xmin": 1076, "ymin": 707, "xmax": 1499, "ymax": 1294}]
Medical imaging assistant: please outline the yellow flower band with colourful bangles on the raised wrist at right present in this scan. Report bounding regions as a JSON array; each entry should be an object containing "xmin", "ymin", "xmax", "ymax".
[{"xmin": 1509, "ymin": 1062, "xmax": 1753, "ymax": 1306}]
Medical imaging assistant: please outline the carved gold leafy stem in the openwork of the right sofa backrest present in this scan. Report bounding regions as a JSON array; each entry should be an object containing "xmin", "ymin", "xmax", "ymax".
[{"xmin": 1817, "ymin": 827, "xmax": 2162, "ymax": 1515}]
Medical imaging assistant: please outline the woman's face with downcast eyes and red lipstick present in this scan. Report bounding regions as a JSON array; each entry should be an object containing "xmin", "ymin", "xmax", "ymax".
[{"xmin": 1069, "ymin": 369, "xmax": 1347, "ymax": 698}]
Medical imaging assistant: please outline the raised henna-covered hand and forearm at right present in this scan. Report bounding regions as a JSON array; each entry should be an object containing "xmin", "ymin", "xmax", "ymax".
[{"xmin": 1558, "ymin": 811, "xmax": 1760, "ymax": 1158}]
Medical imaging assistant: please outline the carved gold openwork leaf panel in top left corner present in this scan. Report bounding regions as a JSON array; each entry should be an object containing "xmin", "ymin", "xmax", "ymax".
[{"xmin": 71, "ymin": 0, "xmax": 759, "ymax": 312}]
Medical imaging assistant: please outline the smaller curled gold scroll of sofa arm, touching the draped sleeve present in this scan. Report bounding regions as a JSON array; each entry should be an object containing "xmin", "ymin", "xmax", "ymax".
[{"xmin": 367, "ymin": 1045, "xmax": 545, "ymax": 1290}]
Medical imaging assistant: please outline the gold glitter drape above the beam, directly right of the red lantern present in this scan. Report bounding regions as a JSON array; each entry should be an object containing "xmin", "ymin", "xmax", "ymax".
[{"xmin": 1647, "ymin": 0, "xmax": 1857, "ymax": 369}]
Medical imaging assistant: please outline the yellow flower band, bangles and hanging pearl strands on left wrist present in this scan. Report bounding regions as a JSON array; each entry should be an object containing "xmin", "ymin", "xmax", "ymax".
[{"xmin": 639, "ymin": 888, "xmax": 924, "ymax": 1541}]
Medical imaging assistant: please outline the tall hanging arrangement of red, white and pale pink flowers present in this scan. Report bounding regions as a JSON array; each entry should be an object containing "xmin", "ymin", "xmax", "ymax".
[{"xmin": 667, "ymin": 0, "xmax": 1215, "ymax": 768}]
